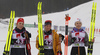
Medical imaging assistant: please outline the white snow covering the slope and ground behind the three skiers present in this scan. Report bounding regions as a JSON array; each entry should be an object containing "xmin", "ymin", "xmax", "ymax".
[{"xmin": 0, "ymin": 0, "xmax": 100, "ymax": 55}]
